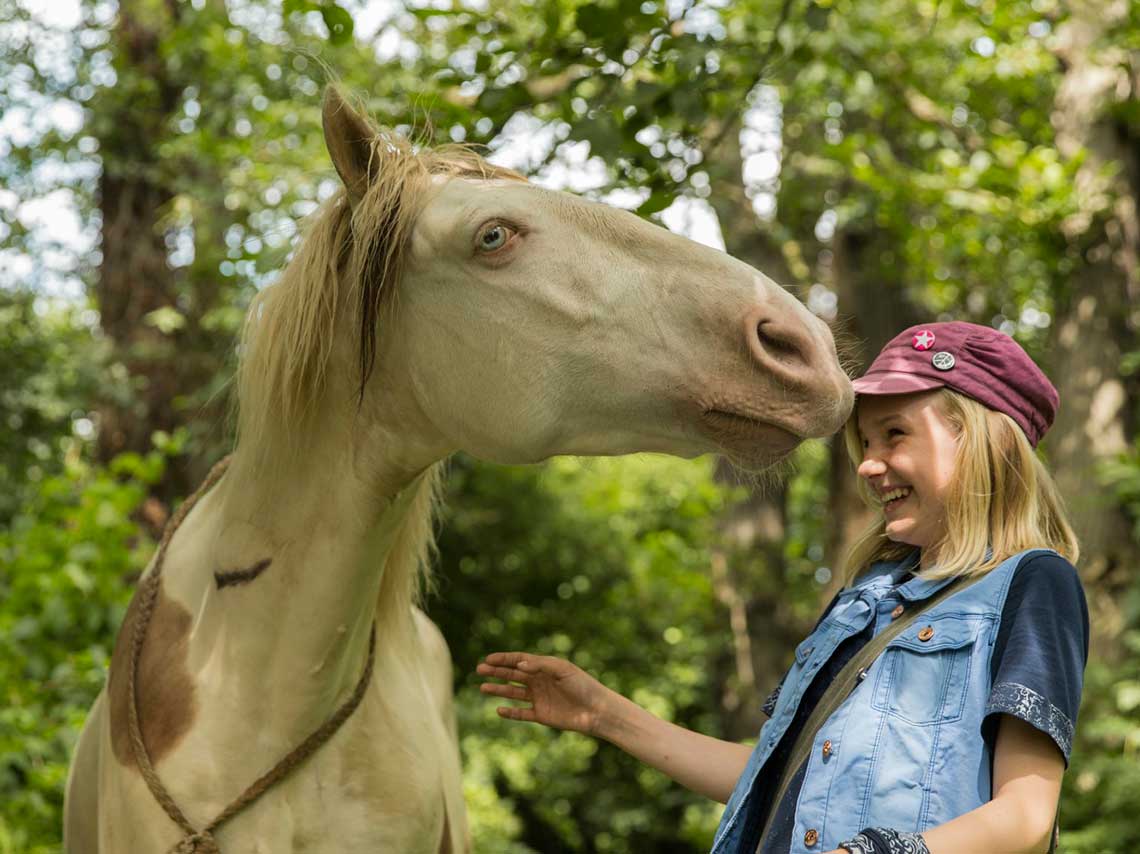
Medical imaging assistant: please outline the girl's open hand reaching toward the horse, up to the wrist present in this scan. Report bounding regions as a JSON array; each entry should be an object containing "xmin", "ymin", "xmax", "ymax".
[{"xmin": 475, "ymin": 652, "xmax": 612, "ymax": 735}]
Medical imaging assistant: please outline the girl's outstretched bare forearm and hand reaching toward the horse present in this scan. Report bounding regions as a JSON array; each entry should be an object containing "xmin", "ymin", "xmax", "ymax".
[{"xmin": 477, "ymin": 652, "xmax": 751, "ymax": 804}]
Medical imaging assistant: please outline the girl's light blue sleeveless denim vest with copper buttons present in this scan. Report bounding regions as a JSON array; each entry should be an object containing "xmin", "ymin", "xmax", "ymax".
[{"xmin": 713, "ymin": 550, "xmax": 1050, "ymax": 854}]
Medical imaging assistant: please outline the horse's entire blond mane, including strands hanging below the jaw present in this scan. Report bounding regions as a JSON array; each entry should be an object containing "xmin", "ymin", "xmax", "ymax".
[{"xmin": 234, "ymin": 108, "xmax": 526, "ymax": 626}]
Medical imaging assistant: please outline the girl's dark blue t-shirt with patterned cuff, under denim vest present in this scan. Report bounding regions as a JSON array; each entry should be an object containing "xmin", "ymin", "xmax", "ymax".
[{"xmin": 747, "ymin": 553, "xmax": 1089, "ymax": 854}]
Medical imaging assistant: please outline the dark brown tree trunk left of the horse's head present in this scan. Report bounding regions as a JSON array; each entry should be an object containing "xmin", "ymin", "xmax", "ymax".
[{"xmin": 93, "ymin": 0, "xmax": 203, "ymax": 503}]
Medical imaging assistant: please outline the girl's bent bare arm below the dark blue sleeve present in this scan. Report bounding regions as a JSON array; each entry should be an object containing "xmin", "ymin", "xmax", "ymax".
[{"xmin": 829, "ymin": 715, "xmax": 1065, "ymax": 854}]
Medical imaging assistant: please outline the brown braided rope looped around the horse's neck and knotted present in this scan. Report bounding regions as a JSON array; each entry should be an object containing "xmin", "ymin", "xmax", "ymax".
[{"xmin": 127, "ymin": 456, "xmax": 376, "ymax": 854}]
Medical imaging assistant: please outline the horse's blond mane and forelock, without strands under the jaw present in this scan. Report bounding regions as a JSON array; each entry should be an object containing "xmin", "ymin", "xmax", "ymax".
[{"xmin": 236, "ymin": 125, "xmax": 527, "ymax": 447}]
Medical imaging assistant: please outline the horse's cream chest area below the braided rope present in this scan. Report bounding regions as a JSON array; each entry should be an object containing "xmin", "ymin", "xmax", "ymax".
[{"xmin": 104, "ymin": 684, "xmax": 464, "ymax": 854}]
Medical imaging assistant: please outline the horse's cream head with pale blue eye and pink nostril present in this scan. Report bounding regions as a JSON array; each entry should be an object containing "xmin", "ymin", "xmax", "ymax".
[{"xmin": 235, "ymin": 90, "xmax": 853, "ymax": 476}]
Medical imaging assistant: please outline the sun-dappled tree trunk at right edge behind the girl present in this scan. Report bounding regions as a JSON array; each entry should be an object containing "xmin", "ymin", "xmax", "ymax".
[{"xmin": 1044, "ymin": 2, "xmax": 1140, "ymax": 652}]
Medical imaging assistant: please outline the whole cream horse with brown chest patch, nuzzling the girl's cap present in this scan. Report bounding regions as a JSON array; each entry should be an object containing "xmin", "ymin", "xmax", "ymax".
[{"xmin": 65, "ymin": 90, "xmax": 853, "ymax": 854}]
